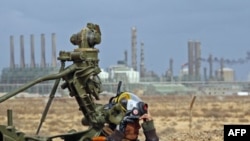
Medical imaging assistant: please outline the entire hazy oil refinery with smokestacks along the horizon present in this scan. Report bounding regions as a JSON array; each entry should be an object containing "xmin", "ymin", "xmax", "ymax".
[{"xmin": 0, "ymin": 27, "xmax": 250, "ymax": 95}]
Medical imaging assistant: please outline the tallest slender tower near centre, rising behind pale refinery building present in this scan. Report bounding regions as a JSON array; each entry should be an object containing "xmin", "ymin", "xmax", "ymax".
[{"xmin": 131, "ymin": 27, "xmax": 137, "ymax": 71}]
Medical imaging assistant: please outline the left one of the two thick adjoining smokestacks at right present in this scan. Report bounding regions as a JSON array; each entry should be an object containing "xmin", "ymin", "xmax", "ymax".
[{"xmin": 188, "ymin": 41, "xmax": 194, "ymax": 77}]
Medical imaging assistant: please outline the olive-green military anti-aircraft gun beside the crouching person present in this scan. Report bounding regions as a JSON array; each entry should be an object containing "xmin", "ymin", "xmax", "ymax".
[{"xmin": 0, "ymin": 23, "xmax": 124, "ymax": 141}]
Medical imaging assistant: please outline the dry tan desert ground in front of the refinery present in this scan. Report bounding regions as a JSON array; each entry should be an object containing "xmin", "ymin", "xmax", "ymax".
[{"xmin": 0, "ymin": 95, "xmax": 250, "ymax": 141}]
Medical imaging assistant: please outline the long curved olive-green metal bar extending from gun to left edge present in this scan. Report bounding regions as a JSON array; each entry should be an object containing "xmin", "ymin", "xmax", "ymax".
[{"xmin": 0, "ymin": 65, "xmax": 77, "ymax": 103}]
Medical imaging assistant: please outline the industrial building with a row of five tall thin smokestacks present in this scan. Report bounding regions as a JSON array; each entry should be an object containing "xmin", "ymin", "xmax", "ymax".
[{"xmin": 0, "ymin": 33, "xmax": 59, "ymax": 94}]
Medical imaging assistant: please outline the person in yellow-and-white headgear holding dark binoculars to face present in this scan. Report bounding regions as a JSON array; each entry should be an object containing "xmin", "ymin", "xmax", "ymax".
[{"xmin": 107, "ymin": 92, "xmax": 159, "ymax": 141}]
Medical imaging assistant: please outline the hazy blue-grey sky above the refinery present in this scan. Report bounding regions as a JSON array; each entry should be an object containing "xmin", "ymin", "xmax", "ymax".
[{"xmin": 0, "ymin": 0, "xmax": 250, "ymax": 80}]
